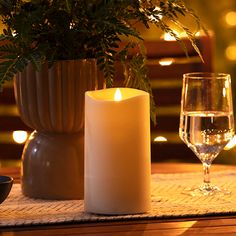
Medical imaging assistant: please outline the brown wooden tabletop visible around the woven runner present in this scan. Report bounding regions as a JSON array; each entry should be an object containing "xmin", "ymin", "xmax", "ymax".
[{"xmin": 0, "ymin": 163, "xmax": 236, "ymax": 236}]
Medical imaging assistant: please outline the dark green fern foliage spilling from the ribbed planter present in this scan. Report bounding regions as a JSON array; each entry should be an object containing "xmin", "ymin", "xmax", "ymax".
[{"xmin": 0, "ymin": 0, "xmax": 204, "ymax": 123}]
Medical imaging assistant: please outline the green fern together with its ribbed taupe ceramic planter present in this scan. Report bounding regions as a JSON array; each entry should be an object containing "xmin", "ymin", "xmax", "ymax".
[{"xmin": 0, "ymin": 0, "xmax": 204, "ymax": 198}]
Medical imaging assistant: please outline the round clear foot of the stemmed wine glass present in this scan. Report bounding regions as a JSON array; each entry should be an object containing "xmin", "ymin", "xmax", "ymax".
[{"xmin": 183, "ymin": 184, "xmax": 231, "ymax": 197}]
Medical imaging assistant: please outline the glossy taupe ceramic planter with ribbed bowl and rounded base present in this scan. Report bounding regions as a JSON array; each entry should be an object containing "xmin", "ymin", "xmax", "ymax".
[{"xmin": 14, "ymin": 59, "xmax": 100, "ymax": 199}]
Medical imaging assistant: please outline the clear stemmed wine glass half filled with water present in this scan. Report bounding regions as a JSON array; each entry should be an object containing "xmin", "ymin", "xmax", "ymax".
[{"xmin": 179, "ymin": 72, "xmax": 234, "ymax": 196}]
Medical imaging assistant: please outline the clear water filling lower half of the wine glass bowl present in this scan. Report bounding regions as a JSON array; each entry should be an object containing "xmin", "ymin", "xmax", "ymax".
[{"xmin": 179, "ymin": 111, "xmax": 234, "ymax": 164}]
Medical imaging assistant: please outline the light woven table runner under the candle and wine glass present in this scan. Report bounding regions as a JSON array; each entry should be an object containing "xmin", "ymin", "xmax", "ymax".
[{"xmin": 0, "ymin": 171, "xmax": 236, "ymax": 227}]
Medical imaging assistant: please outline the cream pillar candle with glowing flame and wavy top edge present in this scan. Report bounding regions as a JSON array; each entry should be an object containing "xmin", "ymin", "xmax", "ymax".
[{"xmin": 84, "ymin": 88, "xmax": 151, "ymax": 214}]
